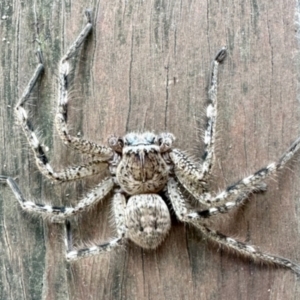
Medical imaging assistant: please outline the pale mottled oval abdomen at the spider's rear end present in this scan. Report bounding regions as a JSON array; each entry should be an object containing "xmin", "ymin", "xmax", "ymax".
[{"xmin": 125, "ymin": 194, "xmax": 171, "ymax": 249}]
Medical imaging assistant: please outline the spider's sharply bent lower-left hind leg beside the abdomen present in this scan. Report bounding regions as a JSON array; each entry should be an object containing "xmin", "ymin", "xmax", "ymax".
[{"xmin": 65, "ymin": 193, "xmax": 126, "ymax": 261}]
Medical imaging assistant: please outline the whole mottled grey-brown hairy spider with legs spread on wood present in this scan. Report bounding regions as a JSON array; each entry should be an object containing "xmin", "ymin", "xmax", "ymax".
[{"xmin": 0, "ymin": 10, "xmax": 300, "ymax": 275}]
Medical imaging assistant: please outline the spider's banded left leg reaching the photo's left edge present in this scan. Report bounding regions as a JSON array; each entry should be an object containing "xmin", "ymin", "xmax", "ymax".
[{"xmin": 0, "ymin": 175, "xmax": 114, "ymax": 223}]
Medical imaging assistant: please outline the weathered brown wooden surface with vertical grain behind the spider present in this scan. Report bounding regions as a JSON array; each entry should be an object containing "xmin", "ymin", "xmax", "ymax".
[{"xmin": 0, "ymin": 0, "xmax": 300, "ymax": 300}]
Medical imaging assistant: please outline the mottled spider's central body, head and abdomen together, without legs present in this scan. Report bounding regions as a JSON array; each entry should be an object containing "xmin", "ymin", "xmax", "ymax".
[{"xmin": 109, "ymin": 132, "xmax": 174, "ymax": 249}]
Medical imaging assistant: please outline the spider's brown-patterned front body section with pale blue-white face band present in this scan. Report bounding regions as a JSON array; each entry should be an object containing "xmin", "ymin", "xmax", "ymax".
[{"xmin": 109, "ymin": 132, "xmax": 174, "ymax": 195}]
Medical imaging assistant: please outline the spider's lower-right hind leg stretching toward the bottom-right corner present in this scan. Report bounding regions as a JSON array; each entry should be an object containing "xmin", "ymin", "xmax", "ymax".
[{"xmin": 168, "ymin": 178, "xmax": 300, "ymax": 275}]
